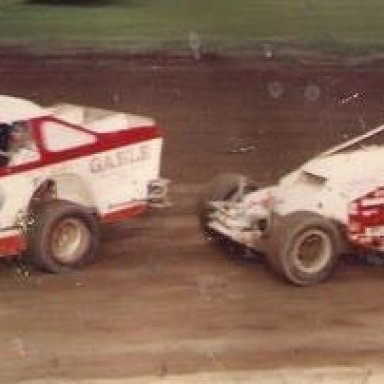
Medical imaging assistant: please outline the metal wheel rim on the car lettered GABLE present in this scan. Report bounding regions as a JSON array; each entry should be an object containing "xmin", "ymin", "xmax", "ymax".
[{"xmin": 50, "ymin": 218, "xmax": 91, "ymax": 264}]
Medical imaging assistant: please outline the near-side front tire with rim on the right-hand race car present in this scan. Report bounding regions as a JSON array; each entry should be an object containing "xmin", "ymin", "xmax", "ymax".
[{"xmin": 267, "ymin": 212, "xmax": 344, "ymax": 286}]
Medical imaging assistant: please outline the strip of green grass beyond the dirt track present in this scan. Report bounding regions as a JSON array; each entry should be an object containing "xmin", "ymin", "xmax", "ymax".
[{"xmin": 0, "ymin": 0, "xmax": 384, "ymax": 51}]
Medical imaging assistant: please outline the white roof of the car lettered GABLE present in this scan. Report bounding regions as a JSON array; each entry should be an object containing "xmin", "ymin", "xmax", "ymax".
[{"xmin": 0, "ymin": 95, "xmax": 48, "ymax": 124}]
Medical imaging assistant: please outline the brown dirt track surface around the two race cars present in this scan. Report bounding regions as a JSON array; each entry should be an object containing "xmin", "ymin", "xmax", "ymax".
[{"xmin": 0, "ymin": 56, "xmax": 384, "ymax": 383}]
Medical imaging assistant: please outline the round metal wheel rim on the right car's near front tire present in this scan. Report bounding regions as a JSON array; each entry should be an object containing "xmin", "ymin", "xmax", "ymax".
[{"xmin": 291, "ymin": 229, "xmax": 333, "ymax": 274}]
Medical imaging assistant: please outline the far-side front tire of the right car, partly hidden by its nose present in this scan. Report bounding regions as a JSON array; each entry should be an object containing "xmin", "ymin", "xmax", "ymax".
[{"xmin": 198, "ymin": 173, "xmax": 258, "ymax": 240}]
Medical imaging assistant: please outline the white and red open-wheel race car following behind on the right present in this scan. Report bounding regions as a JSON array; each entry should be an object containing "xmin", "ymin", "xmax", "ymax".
[{"xmin": 200, "ymin": 126, "xmax": 384, "ymax": 285}]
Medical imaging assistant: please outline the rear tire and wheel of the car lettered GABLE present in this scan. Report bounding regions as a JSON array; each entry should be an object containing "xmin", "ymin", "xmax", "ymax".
[{"xmin": 27, "ymin": 200, "xmax": 100, "ymax": 273}]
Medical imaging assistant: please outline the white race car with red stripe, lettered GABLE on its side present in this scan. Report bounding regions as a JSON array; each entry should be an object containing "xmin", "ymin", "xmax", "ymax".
[{"xmin": 0, "ymin": 96, "xmax": 167, "ymax": 272}]
